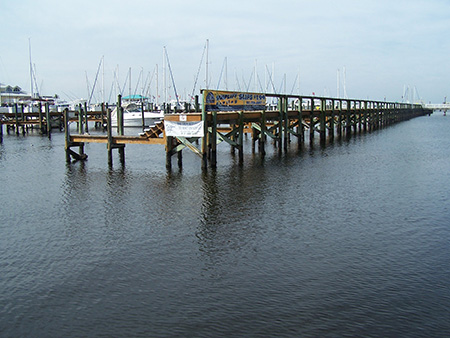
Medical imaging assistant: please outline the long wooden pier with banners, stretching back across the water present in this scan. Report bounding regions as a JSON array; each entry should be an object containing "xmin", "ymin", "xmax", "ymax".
[{"xmin": 59, "ymin": 90, "xmax": 432, "ymax": 169}]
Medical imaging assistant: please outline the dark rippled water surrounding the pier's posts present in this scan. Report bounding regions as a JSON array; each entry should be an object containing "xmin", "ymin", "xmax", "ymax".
[{"xmin": 0, "ymin": 113, "xmax": 450, "ymax": 337}]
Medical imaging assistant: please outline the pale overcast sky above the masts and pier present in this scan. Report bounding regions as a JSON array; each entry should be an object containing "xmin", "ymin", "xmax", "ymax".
[{"xmin": 0, "ymin": 0, "xmax": 450, "ymax": 102}]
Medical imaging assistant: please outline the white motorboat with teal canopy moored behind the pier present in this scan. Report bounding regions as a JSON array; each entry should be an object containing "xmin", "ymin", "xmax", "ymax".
[{"xmin": 111, "ymin": 103, "xmax": 164, "ymax": 127}]
